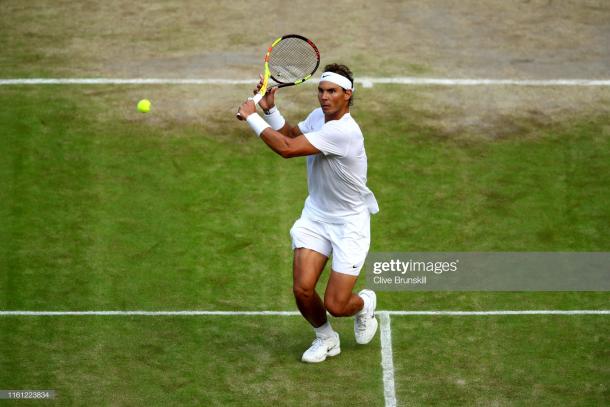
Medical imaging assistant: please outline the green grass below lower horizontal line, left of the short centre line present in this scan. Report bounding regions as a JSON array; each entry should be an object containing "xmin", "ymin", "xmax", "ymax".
[{"xmin": 0, "ymin": 317, "xmax": 383, "ymax": 407}]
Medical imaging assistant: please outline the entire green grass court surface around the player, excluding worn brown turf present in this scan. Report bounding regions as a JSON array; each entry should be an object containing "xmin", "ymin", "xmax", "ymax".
[{"xmin": 0, "ymin": 86, "xmax": 610, "ymax": 406}]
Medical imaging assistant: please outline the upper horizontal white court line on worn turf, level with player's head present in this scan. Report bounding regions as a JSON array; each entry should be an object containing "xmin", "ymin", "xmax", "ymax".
[{"xmin": 0, "ymin": 76, "xmax": 610, "ymax": 88}]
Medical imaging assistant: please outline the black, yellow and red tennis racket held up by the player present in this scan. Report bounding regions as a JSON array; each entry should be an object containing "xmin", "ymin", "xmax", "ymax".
[{"xmin": 237, "ymin": 34, "xmax": 320, "ymax": 116}]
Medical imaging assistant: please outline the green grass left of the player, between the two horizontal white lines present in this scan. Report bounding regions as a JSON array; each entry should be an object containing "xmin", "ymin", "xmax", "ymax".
[{"xmin": 0, "ymin": 89, "xmax": 304, "ymax": 309}]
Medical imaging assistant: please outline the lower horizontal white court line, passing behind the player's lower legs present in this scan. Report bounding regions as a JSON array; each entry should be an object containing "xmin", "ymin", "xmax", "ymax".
[{"xmin": 0, "ymin": 310, "xmax": 610, "ymax": 316}]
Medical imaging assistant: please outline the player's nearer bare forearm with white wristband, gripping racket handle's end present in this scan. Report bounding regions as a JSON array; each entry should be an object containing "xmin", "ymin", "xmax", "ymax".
[{"xmin": 238, "ymin": 100, "xmax": 320, "ymax": 158}]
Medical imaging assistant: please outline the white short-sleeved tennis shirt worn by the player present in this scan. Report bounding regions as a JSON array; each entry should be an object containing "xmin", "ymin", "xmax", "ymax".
[{"xmin": 299, "ymin": 108, "xmax": 379, "ymax": 223}]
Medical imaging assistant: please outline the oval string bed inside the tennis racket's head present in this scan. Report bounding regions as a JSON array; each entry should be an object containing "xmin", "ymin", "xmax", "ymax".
[{"xmin": 269, "ymin": 38, "xmax": 318, "ymax": 83}]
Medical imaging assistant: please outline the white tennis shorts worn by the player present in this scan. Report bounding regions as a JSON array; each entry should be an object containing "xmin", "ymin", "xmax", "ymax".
[{"xmin": 290, "ymin": 211, "xmax": 371, "ymax": 276}]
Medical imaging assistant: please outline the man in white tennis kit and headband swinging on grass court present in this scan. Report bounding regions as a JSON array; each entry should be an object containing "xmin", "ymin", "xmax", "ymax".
[{"xmin": 239, "ymin": 64, "xmax": 379, "ymax": 363}]
